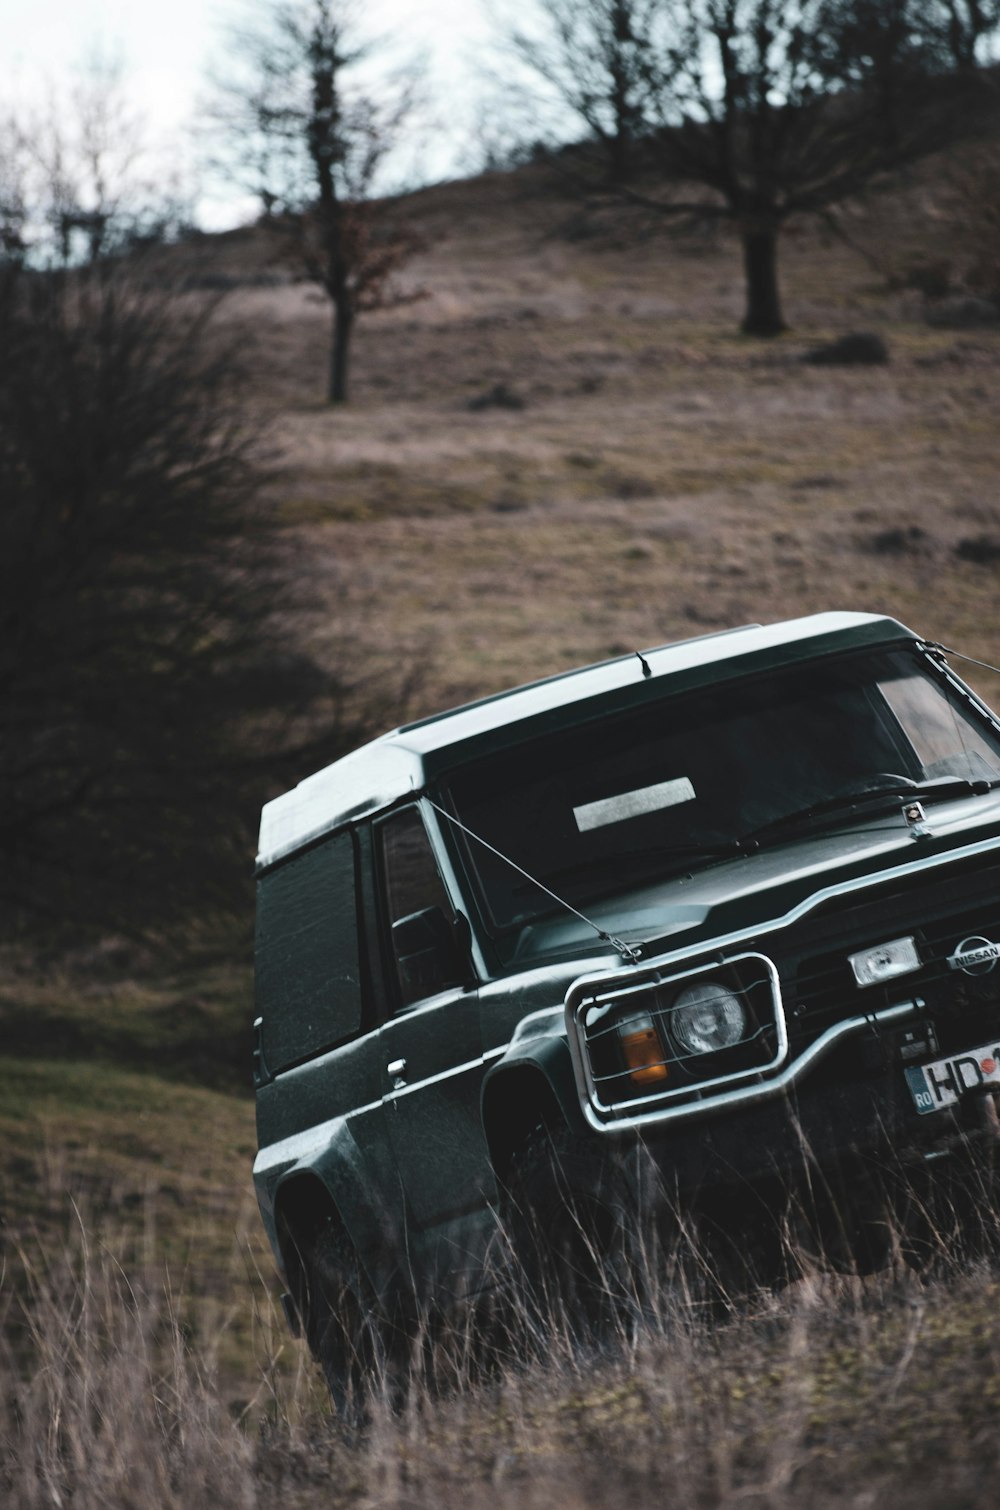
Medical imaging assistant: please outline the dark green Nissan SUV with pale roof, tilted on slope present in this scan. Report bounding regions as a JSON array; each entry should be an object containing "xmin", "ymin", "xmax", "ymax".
[{"xmin": 254, "ymin": 613, "xmax": 1000, "ymax": 1389}]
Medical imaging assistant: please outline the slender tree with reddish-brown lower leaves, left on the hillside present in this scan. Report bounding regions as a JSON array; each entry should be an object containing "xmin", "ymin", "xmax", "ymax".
[{"xmin": 210, "ymin": 0, "xmax": 420, "ymax": 403}]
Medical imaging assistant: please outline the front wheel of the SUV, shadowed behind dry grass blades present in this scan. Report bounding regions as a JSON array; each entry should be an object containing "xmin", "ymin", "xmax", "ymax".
[{"xmin": 503, "ymin": 1126, "xmax": 653, "ymax": 1341}]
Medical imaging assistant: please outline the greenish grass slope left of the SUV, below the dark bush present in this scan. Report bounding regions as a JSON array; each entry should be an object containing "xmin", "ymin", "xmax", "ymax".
[{"xmin": 0, "ymin": 948, "xmax": 272, "ymax": 1400}]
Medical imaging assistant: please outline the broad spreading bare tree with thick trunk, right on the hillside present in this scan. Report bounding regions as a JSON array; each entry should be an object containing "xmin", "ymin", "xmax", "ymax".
[{"xmin": 492, "ymin": 0, "xmax": 995, "ymax": 337}]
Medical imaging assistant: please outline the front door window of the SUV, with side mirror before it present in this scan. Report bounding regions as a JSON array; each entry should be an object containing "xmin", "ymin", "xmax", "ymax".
[{"xmin": 378, "ymin": 808, "xmax": 464, "ymax": 1006}]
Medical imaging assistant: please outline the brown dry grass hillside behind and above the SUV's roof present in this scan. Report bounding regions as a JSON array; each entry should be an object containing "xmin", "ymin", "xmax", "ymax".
[{"xmin": 193, "ymin": 159, "xmax": 1000, "ymax": 711}]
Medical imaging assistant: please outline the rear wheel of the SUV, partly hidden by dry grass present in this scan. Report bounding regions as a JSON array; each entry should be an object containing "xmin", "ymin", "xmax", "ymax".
[{"xmin": 298, "ymin": 1217, "xmax": 393, "ymax": 1425}]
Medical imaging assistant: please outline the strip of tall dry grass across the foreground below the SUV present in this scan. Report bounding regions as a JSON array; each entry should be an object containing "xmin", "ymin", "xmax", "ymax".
[{"xmin": 0, "ymin": 1165, "xmax": 1000, "ymax": 1510}]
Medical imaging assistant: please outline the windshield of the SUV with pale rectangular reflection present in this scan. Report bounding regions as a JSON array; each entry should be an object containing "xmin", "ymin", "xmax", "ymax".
[{"xmin": 449, "ymin": 651, "xmax": 1000, "ymax": 935}]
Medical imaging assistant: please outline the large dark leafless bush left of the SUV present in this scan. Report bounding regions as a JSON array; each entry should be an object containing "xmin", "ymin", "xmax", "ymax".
[{"xmin": 0, "ymin": 258, "xmax": 356, "ymax": 929}]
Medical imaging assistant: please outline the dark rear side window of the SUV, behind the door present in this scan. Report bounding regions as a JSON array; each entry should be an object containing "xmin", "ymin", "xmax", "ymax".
[{"xmin": 255, "ymin": 832, "xmax": 363, "ymax": 1074}]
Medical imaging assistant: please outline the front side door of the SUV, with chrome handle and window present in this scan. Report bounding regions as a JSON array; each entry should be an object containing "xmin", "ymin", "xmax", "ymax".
[{"xmin": 375, "ymin": 805, "xmax": 492, "ymax": 1277}]
